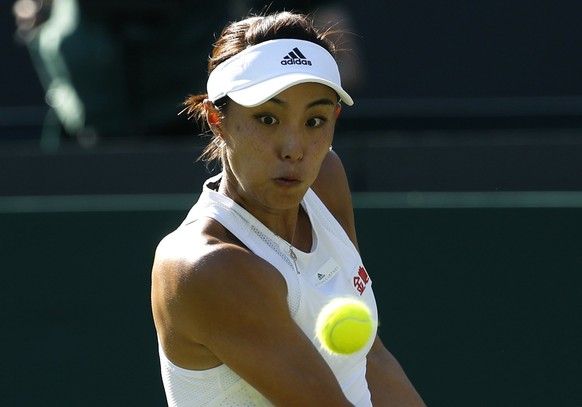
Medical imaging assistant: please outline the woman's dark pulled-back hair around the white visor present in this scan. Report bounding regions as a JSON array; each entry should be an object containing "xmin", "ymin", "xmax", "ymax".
[{"xmin": 183, "ymin": 11, "xmax": 336, "ymax": 166}]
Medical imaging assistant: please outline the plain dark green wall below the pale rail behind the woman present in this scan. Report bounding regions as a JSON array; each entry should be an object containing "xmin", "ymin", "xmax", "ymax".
[{"xmin": 0, "ymin": 208, "xmax": 582, "ymax": 407}]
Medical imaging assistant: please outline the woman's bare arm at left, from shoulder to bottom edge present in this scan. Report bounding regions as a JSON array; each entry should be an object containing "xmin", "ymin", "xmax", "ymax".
[{"xmin": 151, "ymin": 231, "xmax": 349, "ymax": 406}]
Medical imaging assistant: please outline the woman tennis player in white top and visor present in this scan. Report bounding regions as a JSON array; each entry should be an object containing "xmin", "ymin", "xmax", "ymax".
[{"xmin": 152, "ymin": 12, "xmax": 423, "ymax": 407}]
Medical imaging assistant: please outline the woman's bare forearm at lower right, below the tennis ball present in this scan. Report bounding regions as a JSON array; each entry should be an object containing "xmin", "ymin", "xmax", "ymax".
[{"xmin": 366, "ymin": 338, "xmax": 425, "ymax": 407}]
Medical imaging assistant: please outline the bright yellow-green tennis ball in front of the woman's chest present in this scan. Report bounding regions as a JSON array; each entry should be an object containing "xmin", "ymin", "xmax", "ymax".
[{"xmin": 315, "ymin": 298, "xmax": 374, "ymax": 355}]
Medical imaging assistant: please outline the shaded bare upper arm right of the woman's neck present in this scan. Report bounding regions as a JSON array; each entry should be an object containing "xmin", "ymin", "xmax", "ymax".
[{"xmin": 312, "ymin": 150, "xmax": 357, "ymax": 247}]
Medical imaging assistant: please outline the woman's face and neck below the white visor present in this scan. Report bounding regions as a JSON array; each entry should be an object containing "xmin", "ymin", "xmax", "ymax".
[{"xmin": 206, "ymin": 83, "xmax": 339, "ymax": 242}]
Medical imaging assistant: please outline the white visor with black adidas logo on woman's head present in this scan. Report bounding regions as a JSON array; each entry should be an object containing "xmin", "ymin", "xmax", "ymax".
[{"xmin": 207, "ymin": 39, "xmax": 354, "ymax": 107}]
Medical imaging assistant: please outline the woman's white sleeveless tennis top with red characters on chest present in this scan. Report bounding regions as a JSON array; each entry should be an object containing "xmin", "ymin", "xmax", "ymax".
[{"xmin": 159, "ymin": 175, "xmax": 378, "ymax": 407}]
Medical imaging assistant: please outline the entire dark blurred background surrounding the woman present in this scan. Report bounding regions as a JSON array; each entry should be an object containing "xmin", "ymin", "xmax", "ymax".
[{"xmin": 0, "ymin": 0, "xmax": 582, "ymax": 407}]
